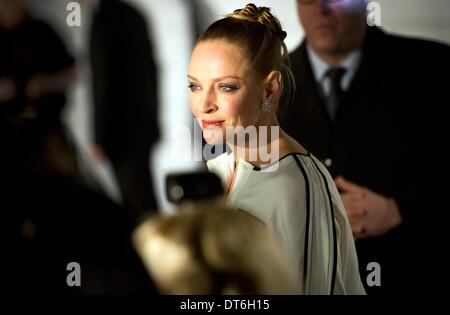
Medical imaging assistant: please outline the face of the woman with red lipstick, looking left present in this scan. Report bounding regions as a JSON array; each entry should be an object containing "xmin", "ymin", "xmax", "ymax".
[{"xmin": 188, "ymin": 40, "xmax": 264, "ymax": 143}]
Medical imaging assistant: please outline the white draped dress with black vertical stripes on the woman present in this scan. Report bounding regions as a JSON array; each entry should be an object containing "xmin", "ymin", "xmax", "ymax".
[{"xmin": 207, "ymin": 153, "xmax": 365, "ymax": 294}]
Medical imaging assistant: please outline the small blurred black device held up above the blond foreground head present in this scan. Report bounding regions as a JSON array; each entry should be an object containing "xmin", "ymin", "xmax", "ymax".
[{"xmin": 166, "ymin": 171, "xmax": 224, "ymax": 204}]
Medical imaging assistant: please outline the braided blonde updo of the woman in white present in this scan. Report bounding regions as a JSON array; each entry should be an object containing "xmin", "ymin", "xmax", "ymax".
[{"xmin": 198, "ymin": 3, "xmax": 295, "ymax": 113}]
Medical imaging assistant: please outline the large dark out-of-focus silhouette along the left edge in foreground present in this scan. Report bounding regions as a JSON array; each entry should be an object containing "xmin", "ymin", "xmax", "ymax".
[{"xmin": 0, "ymin": 0, "xmax": 154, "ymax": 295}]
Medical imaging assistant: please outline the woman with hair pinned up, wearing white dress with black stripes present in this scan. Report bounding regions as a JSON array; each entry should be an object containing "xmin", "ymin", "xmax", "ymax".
[{"xmin": 188, "ymin": 4, "xmax": 365, "ymax": 294}]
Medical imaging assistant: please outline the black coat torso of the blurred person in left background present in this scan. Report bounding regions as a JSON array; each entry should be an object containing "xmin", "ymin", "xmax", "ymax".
[{"xmin": 90, "ymin": 0, "xmax": 159, "ymax": 158}]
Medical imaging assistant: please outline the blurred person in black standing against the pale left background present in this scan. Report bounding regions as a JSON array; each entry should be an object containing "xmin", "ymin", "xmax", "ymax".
[{"xmin": 90, "ymin": 0, "xmax": 159, "ymax": 225}]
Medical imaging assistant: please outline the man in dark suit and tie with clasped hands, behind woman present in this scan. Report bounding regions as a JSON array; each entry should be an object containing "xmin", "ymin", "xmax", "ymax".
[{"xmin": 280, "ymin": 0, "xmax": 450, "ymax": 294}]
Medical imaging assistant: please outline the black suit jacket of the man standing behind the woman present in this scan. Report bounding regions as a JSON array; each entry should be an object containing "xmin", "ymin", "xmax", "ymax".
[{"xmin": 280, "ymin": 28, "xmax": 450, "ymax": 294}]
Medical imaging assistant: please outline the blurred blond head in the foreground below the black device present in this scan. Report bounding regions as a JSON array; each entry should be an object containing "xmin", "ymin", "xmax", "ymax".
[{"xmin": 134, "ymin": 204, "xmax": 299, "ymax": 294}]
